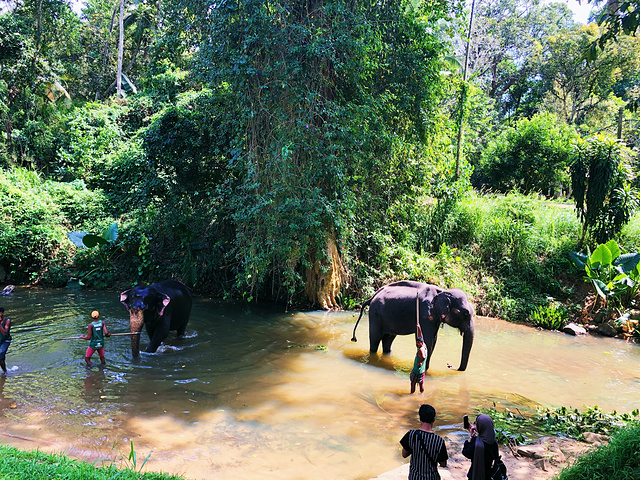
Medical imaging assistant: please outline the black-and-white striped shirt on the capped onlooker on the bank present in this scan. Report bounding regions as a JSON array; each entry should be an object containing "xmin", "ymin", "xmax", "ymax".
[{"xmin": 400, "ymin": 430, "xmax": 449, "ymax": 480}]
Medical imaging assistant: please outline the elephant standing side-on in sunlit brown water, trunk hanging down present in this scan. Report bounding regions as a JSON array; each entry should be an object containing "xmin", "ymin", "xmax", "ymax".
[{"xmin": 351, "ymin": 280, "xmax": 474, "ymax": 371}]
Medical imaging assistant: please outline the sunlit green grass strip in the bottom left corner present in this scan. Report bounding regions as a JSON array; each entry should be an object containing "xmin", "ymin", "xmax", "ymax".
[{"xmin": 0, "ymin": 445, "xmax": 183, "ymax": 480}]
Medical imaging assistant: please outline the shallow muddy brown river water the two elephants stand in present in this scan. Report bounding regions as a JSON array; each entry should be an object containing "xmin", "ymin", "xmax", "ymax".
[{"xmin": 0, "ymin": 289, "xmax": 640, "ymax": 480}]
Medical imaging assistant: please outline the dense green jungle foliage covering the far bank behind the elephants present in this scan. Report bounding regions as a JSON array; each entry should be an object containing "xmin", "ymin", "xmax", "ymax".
[{"xmin": 0, "ymin": 0, "xmax": 640, "ymax": 318}]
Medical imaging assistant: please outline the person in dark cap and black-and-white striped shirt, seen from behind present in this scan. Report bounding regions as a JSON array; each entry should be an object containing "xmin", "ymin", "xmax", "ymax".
[{"xmin": 400, "ymin": 405, "xmax": 449, "ymax": 480}]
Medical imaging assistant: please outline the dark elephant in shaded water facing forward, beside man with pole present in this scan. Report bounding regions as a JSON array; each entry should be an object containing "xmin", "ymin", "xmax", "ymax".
[{"xmin": 120, "ymin": 280, "xmax": 192, "ymax": 357}]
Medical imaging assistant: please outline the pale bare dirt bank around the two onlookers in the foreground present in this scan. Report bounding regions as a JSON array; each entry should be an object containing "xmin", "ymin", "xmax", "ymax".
[{"xmin": 372, "ymin": 437, "xmax": 593, "ymax": 480}]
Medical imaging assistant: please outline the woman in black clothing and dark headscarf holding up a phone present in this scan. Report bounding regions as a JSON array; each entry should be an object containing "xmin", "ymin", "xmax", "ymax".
[{"xmin": 462, "ymin": 414, "xmax": 500, "ymax": 480}]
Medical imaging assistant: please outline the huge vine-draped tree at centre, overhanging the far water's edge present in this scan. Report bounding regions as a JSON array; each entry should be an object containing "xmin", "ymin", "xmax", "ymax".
[{"xmin": 182, "ymin": 0, "xmax": 458, "ymax": 306}]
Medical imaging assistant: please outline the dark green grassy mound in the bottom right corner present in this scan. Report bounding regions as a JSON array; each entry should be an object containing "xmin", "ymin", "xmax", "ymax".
[{"xmin": 556, "ymin": 423, "xmax": 640, "ymax": 480}]
